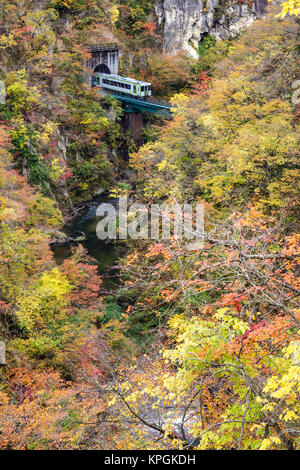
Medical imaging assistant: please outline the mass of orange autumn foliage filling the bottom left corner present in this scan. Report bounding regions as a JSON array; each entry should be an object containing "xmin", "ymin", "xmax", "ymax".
[{"xmin": 0, "ymin": 368, "xmax": 104, "ymax": 450}]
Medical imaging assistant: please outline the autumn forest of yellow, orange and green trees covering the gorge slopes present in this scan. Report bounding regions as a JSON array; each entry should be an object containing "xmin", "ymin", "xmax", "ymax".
[{"xmin": 0, "ymin": 0, "xmax": 300, "ymax": 451}]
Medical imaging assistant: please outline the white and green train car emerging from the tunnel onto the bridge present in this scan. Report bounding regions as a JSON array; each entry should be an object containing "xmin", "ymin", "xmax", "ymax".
[{"xmin": 92, "ymin": 73, "xmax": 152, "ymax": 100}]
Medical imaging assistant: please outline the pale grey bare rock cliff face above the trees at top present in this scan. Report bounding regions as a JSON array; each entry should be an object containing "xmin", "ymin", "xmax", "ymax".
[{"xmin": 155, "ymin": 0, "xmax": 267, "ymax": 58}]
